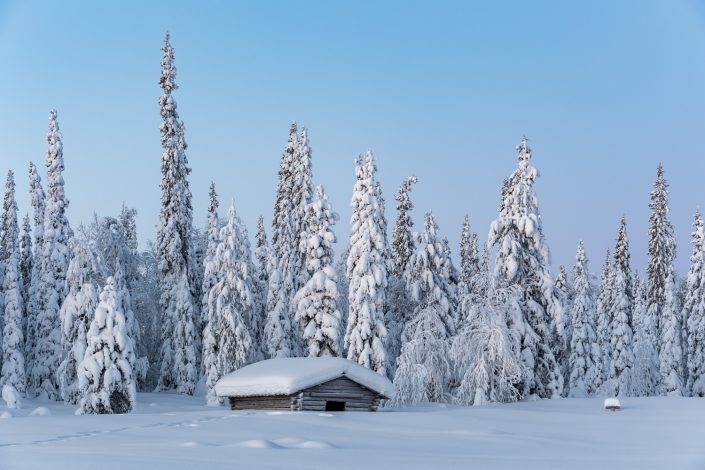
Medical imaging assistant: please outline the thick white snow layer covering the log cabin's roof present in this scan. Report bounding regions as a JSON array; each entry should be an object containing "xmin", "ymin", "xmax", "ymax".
[{"xmin": 215, "ymin": 357, "xmax": 394, "ymax": 398}]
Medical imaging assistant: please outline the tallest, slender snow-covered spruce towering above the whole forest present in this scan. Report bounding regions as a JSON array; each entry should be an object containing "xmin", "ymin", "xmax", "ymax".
[{"xmin": 157, "ymin": 32, "xmax": 198, "ymax": 395}]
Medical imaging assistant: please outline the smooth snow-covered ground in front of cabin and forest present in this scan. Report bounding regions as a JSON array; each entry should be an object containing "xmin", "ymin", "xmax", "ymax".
[{"xmin": 0, "ymin": 394, "xmax": 705, "ymax": 470}]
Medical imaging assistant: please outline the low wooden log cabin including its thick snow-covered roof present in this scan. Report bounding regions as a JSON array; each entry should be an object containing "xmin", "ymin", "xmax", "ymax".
[{"xmin": 216, "ymin": 357, "xmax": 393, "ymax": 411}]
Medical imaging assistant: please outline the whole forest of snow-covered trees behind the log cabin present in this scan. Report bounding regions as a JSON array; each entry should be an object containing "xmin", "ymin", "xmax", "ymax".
[{"xmin": 0, "ymin": 33, "xmax": 705, "ymax": 414}]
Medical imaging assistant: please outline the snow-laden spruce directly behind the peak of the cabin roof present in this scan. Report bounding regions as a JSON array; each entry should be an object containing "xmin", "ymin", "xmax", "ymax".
[{"xmin": 294, "ymin": 186, "xmax": 340, "ymax": 357}]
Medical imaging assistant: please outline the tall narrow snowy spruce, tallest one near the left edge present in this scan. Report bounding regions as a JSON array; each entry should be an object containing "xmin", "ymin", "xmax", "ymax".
[{"xmin": 32, "ymin": 110, "xmax": 70, "ymax": 400}]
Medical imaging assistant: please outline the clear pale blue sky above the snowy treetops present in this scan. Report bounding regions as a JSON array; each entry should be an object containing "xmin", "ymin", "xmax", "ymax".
[{"xmin": 0, "ymin": 0, "xmax": 705, "ymax": 273}]
